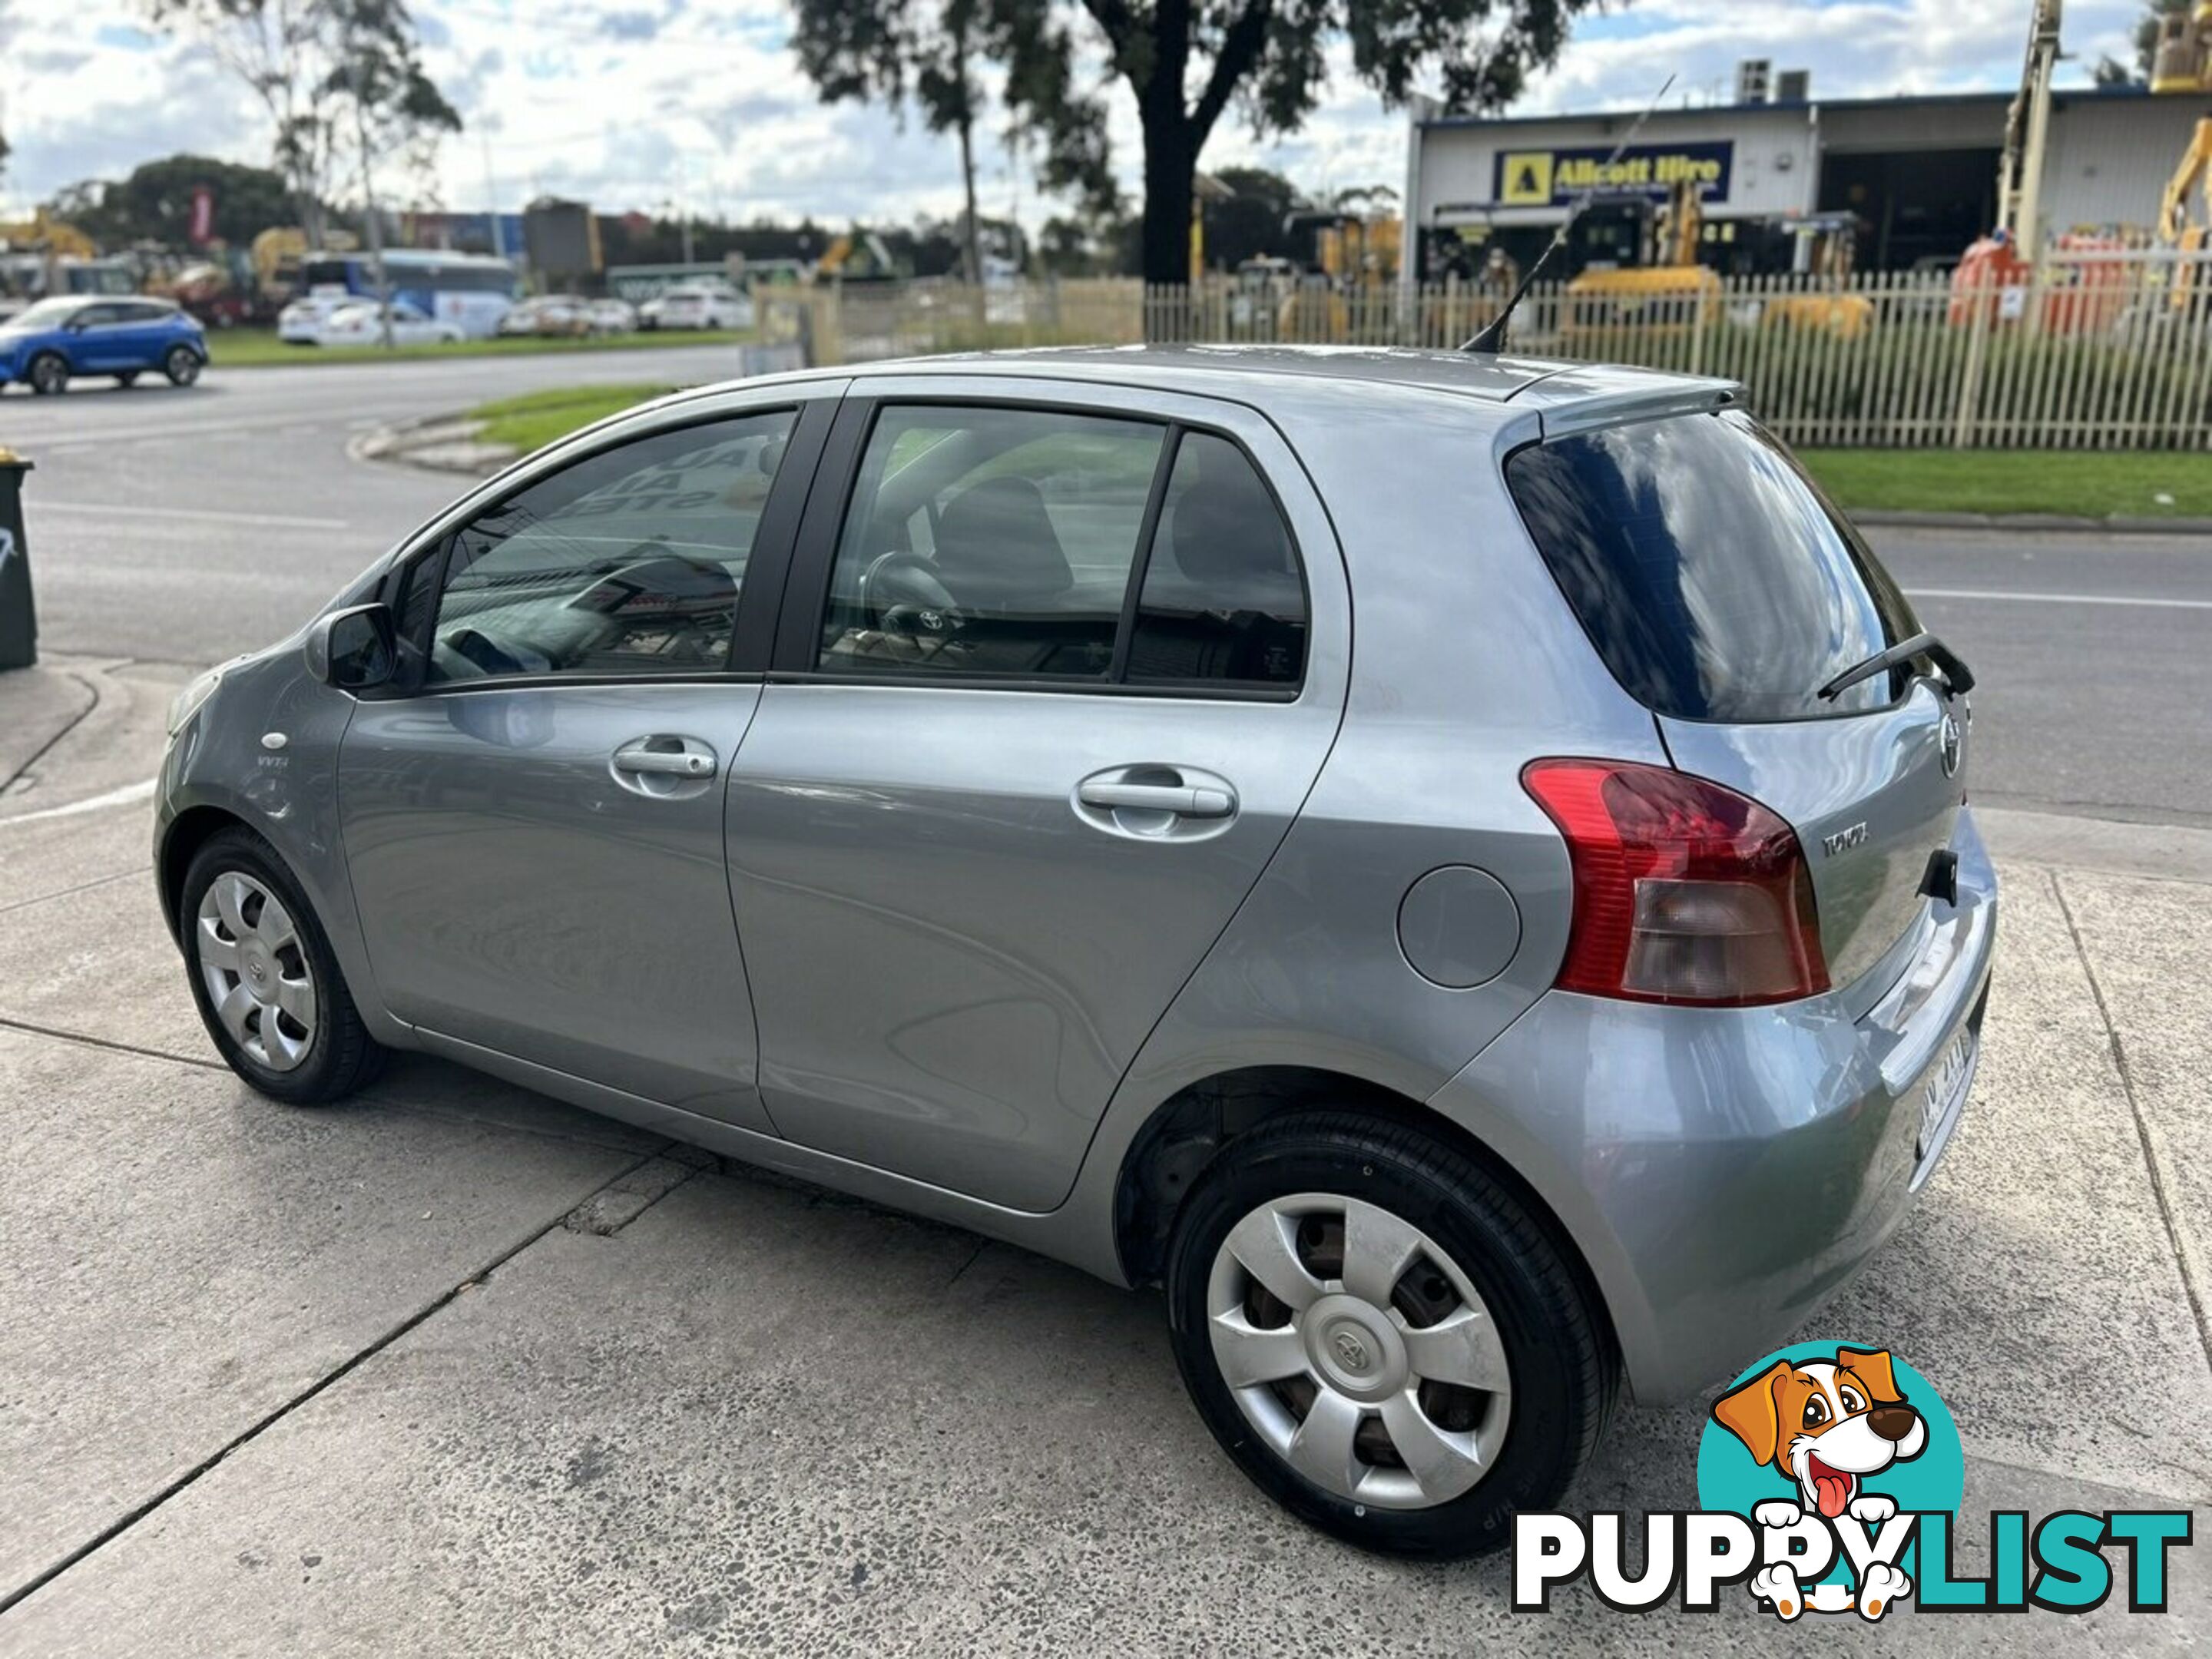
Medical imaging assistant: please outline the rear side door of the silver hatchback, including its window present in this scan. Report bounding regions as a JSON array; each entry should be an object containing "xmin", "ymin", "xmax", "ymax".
[{"xmin": 728, "ymin": 376, "xmax": 1349, "ymax": 1210}]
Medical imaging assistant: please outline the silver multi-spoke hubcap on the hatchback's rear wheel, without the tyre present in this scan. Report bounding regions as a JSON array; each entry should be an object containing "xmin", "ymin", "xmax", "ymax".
[{"xmin": 1206, "ymin": 1192, "xmax": 1513, "ymax": 1508}]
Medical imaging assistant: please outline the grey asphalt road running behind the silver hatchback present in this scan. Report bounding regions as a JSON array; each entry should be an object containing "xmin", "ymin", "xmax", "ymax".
[{"xmin": 0, "ymin": 358, "xmax": 2212, "ymax": 827}]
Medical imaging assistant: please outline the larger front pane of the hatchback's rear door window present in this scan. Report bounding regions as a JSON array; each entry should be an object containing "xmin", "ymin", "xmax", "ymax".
[{"xmin": 819, "ymin": 407, "xmax": 1166, "ymax": 679}]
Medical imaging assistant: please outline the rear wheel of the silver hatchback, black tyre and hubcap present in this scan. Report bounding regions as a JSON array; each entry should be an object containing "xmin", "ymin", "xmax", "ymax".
[{"xmin": 1168, "ymin": 1113, "xmax": 1617, "ymax": 1558}]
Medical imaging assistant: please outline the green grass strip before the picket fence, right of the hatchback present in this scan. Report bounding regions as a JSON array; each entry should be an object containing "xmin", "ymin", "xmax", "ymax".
[{"xmin": 1798, "ymin": 449, "xmax": 2212, "ymax": 518}]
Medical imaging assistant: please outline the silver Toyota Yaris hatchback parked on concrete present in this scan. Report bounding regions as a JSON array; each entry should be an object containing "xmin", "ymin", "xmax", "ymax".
[{"xmin": 157, "ymin": 349, "xmax": 1998, "ymax": 1555}]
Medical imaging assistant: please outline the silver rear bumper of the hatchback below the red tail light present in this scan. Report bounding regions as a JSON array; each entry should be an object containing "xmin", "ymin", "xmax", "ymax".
[{"xmin": 1429, "ymin": 810, "xmax": 1998, "ymax": 1400}]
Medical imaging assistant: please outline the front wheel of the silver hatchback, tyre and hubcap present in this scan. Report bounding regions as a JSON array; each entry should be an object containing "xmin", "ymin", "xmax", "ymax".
[{"xmin": 179, "ymin": 825, "xmax": 385, "ymax": 1106}]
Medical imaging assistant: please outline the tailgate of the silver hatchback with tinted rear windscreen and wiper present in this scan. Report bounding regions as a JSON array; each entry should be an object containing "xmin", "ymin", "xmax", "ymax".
[{"xmin": 1506, "ymin": 414, "xmax": 1971, "ymax": 1008}]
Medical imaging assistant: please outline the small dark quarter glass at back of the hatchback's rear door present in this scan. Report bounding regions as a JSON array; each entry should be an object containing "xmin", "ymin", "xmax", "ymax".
[{"xmin": 1128, "ymin": 432, "xmax": 1305, "ymax": 686}]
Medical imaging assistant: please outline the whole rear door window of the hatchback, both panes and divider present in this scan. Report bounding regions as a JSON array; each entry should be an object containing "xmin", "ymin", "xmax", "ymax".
[{"xmin": 816, "ymin": 405, "xmax": 1307, "ymax": 690}]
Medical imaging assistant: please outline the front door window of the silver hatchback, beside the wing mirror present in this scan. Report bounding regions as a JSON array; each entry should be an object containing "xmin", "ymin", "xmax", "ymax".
[{"xmin": 427, "ymin": 409, "xmax": 796, "ymax": 681}]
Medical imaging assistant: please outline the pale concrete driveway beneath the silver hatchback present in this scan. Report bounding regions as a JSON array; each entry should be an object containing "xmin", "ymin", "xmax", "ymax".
[{"xmin": 0, "ymin": 659, "xmax": 2212, "ymax": 1654}]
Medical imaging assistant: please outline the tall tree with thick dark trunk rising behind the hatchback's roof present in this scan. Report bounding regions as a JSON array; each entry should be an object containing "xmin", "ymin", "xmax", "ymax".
[{"xmin": 924, "ymin": 0, "xmax": 1599, "ymax": 296}]
